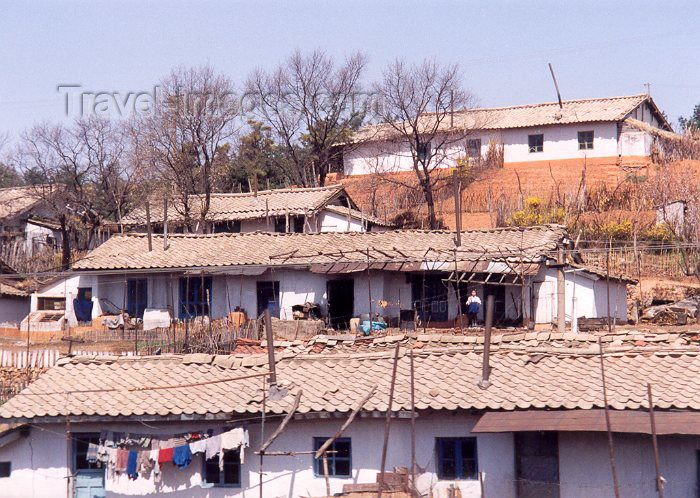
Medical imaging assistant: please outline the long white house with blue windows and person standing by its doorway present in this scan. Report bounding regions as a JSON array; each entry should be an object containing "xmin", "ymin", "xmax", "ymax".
[{"xmin": 26, "ymin": 225, "xmax": 629, "ymax": 329}]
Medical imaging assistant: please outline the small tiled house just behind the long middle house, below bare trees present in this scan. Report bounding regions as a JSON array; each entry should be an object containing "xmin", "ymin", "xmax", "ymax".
[{"xmin": 122, "ymin": 185, "xmax": 392, "ymax": 233}]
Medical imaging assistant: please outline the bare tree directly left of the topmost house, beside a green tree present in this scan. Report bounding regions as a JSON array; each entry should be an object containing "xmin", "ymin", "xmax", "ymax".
[{"xmin": 246, "ymin": 50, "xmax": 366, "ymax": 186}]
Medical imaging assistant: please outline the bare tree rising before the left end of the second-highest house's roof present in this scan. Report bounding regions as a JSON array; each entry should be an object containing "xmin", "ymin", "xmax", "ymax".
[{"xmin": 133, "ymin": 66, "xmax": 240, "ymax": 232}]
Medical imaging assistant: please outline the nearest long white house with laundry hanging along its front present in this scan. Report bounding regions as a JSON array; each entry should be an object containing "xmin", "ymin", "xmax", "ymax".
[{"xmin": 0, "ymin": 334, "xmax": 700, "ymax": 498}]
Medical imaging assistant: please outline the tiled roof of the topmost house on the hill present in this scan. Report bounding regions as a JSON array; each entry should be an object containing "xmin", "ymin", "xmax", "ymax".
[{"xmin": 354, "ymin": 94, "xmax": 668, "ymax": 142}]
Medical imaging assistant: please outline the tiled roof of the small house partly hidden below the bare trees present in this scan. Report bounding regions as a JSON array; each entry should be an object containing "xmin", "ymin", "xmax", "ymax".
[{"xmin": 122, "ymin": 184, "xmax": 344, "ymax": 225}]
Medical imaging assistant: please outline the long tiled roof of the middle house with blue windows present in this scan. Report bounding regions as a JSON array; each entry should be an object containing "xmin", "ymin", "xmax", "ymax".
[{"xmin": 73, "ymin": 225, "xmax": 566, "ymax": 270}]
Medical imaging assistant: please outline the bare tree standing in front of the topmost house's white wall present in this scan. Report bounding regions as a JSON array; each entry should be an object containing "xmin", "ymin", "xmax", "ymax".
[{"xmin": 372, "ymin": 60, "xmax": 484, "ymax": 228}]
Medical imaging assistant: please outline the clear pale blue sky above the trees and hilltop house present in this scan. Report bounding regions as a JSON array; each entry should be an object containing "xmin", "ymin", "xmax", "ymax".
[{"xmin": 0, "ymin": 0, "xmax": 700, "ymax": 140}]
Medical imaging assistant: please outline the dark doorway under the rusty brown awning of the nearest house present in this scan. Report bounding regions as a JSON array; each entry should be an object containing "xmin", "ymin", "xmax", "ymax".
[{"xmin": 515, "ymin": 432, "xmax": 559, "ymax": 498}]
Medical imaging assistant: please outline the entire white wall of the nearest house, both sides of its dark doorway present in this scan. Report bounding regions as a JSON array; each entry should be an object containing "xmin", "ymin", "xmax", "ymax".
[{"xmin": 5, "ymin": 414, "xmax": 700, "ymax": 498}]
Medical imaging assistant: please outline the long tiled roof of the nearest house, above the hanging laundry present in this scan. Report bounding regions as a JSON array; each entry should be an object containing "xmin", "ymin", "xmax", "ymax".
[{"xmin": 0, "ymin": 346, "xmax": 700, "ymax": 422}]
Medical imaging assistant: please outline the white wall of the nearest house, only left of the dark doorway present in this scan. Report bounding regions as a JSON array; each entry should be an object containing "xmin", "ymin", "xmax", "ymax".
[{"xmin": 0, "ymin": 414, "xmax": 515, "ymax": 498}]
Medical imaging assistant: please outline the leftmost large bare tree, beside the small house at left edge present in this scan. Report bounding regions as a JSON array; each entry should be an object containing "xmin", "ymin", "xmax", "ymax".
[{"xmin": 15, "ymin": 117, "xmax": 133, "ymax": 268}]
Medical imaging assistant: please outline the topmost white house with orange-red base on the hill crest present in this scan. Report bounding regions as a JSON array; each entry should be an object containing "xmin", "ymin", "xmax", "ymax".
[{"xmin": 343, "ymin": 95, "xmax": 671, "ymax": 176}]
